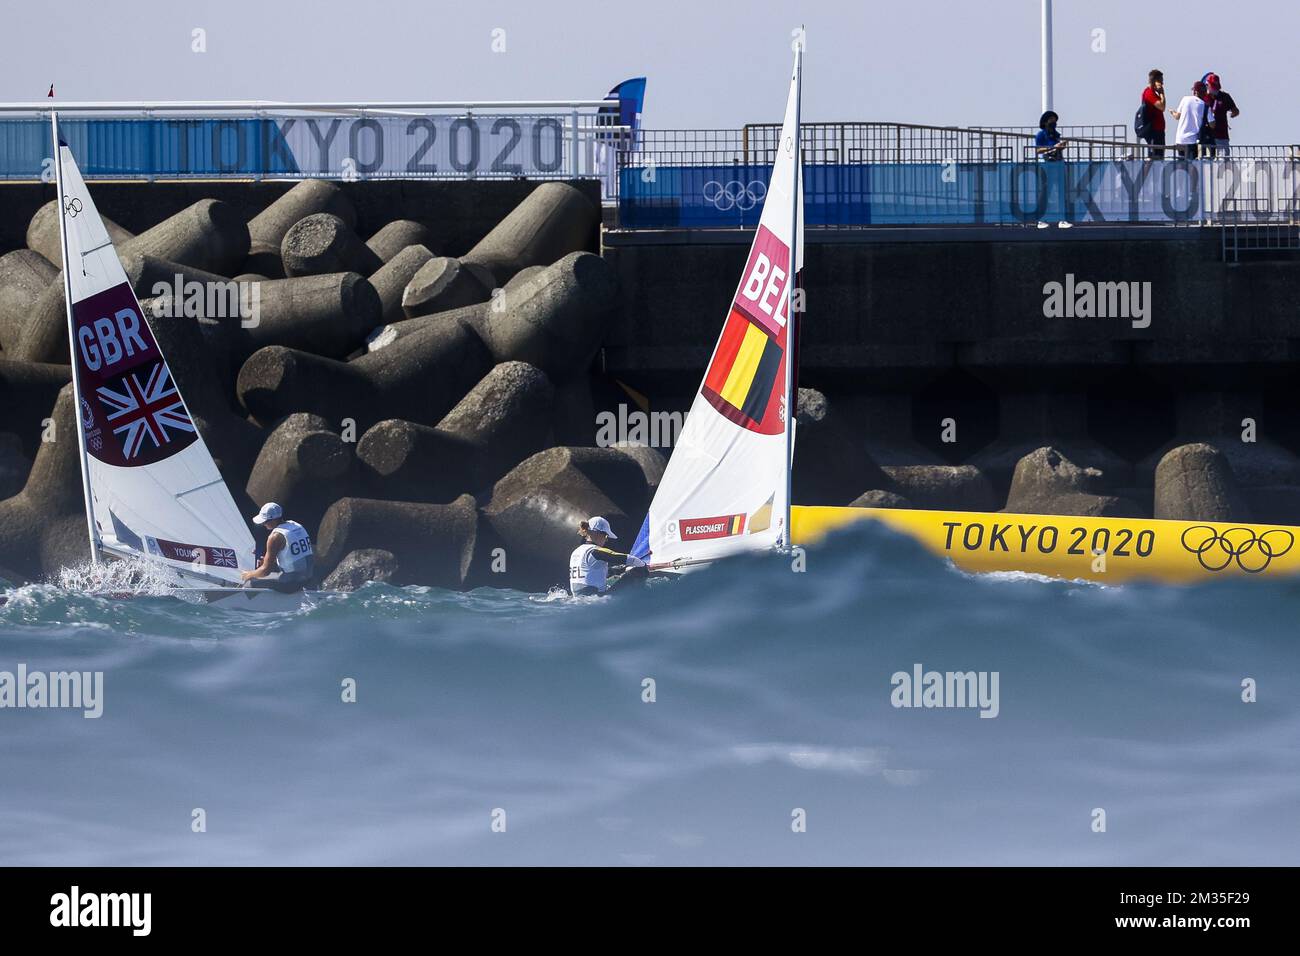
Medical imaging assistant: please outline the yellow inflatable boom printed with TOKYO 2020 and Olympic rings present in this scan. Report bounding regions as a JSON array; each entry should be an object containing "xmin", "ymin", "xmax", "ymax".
[{"xmin": 790, "ymin": 505, "xmax": 1300, "ymax": 584}]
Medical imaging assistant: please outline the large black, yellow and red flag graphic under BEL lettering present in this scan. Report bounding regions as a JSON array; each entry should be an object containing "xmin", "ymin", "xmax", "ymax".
[{"xmin": 702, "ymin": 306, "xmax": 785, "ymax": 434}]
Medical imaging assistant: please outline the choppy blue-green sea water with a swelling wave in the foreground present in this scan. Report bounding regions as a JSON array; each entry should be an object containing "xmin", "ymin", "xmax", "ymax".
[{"xmin": 0, "ymin": 524, "xmax": 1300, "ymax": 865}]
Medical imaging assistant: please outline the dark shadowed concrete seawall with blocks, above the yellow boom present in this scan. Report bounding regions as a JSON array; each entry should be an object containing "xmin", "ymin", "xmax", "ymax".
[{"xmin": 601, "ymin": 226, "xmax": 1300, "ymax": 524}]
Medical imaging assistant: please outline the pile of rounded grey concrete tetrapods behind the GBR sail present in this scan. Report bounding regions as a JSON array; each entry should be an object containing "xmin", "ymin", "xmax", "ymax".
[{"xmin": 0, "ymin": 174, "xmax": 644, "ymax": 588}]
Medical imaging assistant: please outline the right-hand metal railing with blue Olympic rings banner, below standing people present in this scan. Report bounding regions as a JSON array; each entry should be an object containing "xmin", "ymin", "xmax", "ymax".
[{"xmin": 615, "ymin": 124, "xmax": 1300, "ymax": 229}]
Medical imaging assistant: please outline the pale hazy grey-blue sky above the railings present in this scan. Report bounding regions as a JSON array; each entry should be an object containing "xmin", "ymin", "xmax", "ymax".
[{"xmin": 0, "ymin": 0, "xmax": 1300, "ymax": 143}]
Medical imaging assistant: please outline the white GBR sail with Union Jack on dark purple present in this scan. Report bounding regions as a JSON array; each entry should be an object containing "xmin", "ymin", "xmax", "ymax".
[{"xmin": 52, "ymin": 117, "xmax": 255, "ymax": 583}]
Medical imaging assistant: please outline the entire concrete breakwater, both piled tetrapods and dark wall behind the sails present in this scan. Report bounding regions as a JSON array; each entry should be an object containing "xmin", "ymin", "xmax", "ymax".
[{"xmin": 0, "ymin": 174, "xmax": 1300, "ymax": 589}]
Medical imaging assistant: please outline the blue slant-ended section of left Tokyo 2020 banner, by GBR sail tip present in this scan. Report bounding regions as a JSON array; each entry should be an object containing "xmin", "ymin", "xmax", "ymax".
[{"xmin": 0, "ymin": 118, "xmax": 299, "ymax": 179}]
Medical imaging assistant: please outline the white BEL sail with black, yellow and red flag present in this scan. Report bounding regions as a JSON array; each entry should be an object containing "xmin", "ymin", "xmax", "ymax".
[{"xmin": 634, "ymin": 51, "xmax": 803, "ymax": 564}]
